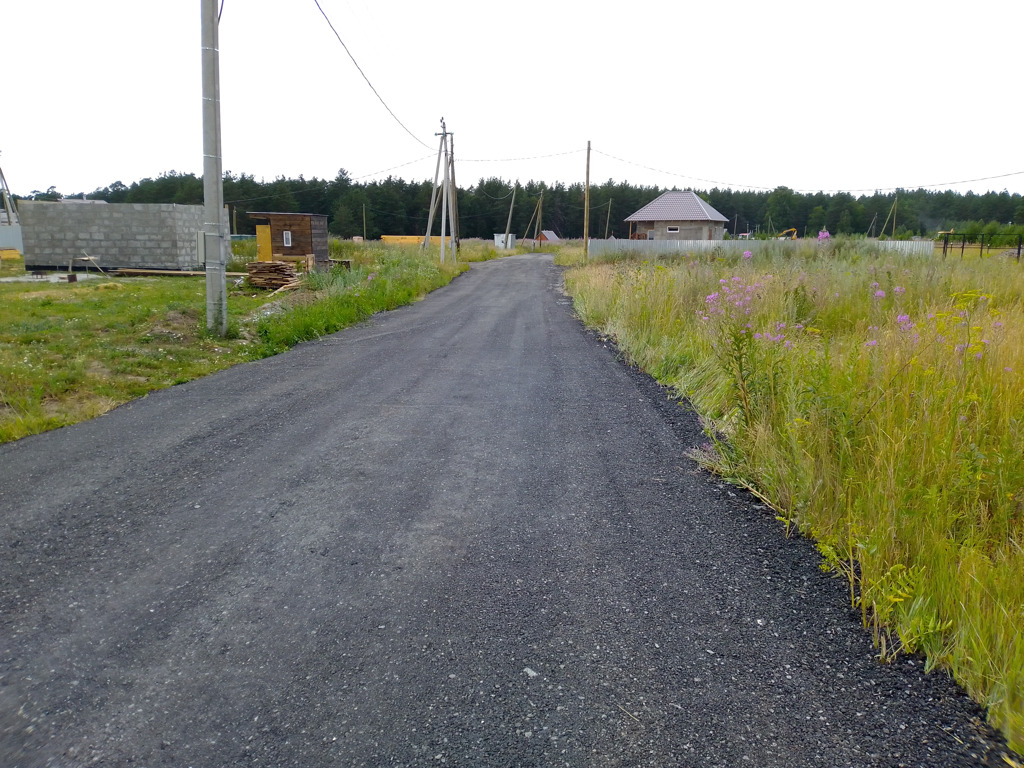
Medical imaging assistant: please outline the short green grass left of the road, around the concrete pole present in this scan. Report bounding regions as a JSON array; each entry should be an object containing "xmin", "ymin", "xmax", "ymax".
[{"xmin": 0, "ymin": 242, "xmax": 483, "ymax": 442}]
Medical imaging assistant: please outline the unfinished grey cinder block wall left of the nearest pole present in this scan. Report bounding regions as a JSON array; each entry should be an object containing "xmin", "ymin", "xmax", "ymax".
[{"xmin": 17, "ymin": 201, "xmax": 203, "ymax": 270}]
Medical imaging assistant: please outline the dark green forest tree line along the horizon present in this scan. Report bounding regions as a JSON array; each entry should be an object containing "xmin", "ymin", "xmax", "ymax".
[{"xmin": 24, "ymin": 170, "xmax": 1024, "ymax": 240}]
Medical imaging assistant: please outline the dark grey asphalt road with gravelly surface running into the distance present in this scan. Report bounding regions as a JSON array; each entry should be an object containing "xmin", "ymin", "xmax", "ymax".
[{"xmin": 0, "ymin": 255, "xmax": 1006, "ymax": 768}]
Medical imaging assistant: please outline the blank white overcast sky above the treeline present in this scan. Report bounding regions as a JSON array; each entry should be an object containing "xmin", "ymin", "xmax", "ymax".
[{"xmin": 0, "ymin": 0, "xmax": 1024, "ymax": 195}]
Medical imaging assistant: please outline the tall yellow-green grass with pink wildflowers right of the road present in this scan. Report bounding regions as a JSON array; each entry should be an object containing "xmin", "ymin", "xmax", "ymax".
[{"xmin": 559, "ymin": 239, "xmax": 1024, "ymax": 751}]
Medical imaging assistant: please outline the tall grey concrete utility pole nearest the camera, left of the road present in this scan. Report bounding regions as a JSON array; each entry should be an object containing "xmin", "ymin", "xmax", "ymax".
[{"xmin": 201, "ymin": 0, "xmax": 227, "ymax": 336}]
